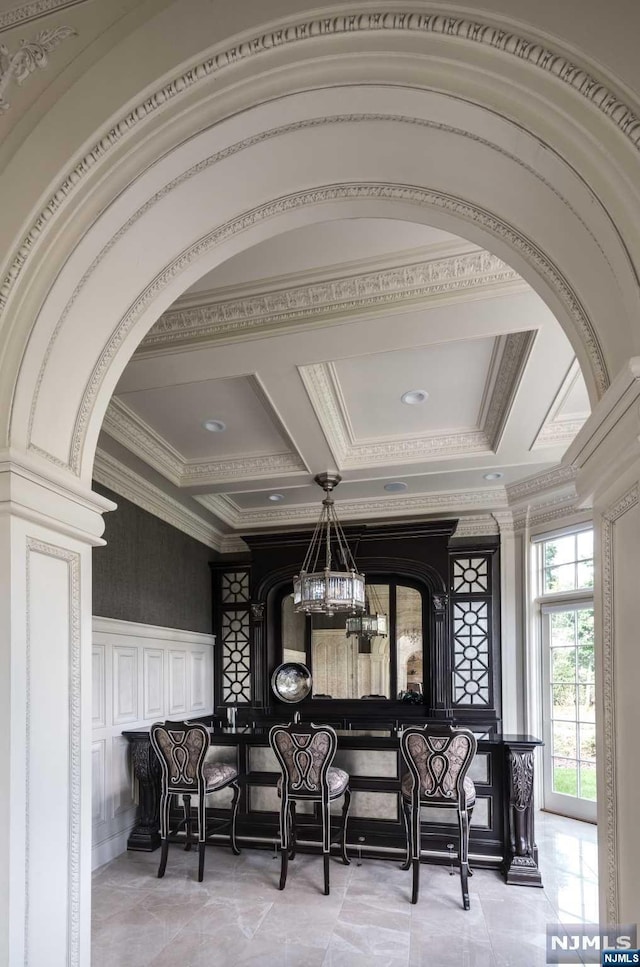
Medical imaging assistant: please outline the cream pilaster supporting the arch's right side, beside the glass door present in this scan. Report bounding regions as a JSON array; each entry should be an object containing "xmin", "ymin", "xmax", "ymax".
[{"xmin": 566, "ymin": 358, "xmax": 640, "ymax": 924}]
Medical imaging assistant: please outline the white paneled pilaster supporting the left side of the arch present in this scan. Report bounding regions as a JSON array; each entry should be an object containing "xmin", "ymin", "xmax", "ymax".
[{"xmin": 0, "ymin": 454, "xmax": 114, "ymax": 967}]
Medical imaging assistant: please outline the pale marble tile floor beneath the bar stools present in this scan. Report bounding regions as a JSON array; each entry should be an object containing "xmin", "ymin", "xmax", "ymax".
[{"xmin": 91, "ymin": 813, "xmax": 598, "ymax": 967}]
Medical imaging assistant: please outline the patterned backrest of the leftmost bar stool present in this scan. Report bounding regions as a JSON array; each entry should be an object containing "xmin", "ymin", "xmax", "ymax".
[{"xmin": 151, "ymin": 722, "xmax": 209, "ymax": 794}]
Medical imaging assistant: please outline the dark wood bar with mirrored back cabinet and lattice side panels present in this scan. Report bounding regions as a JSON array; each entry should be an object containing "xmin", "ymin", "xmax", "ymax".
[{"xmin": 124, "ymin": 520, "xmax": 542, "ymax": 886}]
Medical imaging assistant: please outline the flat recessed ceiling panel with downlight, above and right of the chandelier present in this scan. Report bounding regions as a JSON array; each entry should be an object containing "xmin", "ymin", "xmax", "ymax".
[{"xmin": 333, "ymin": 338, "xmax": 495, "ymax": 441}]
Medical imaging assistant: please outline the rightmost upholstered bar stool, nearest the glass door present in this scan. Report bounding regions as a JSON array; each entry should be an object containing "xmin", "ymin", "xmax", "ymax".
[{"xmin": 400, "ymin": 725, "xmax": 478, "ymax": 910}]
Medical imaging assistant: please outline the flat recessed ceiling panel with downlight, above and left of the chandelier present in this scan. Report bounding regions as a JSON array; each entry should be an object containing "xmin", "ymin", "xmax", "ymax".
[{"xmin": 118, "ymin": 376, "xmax": 291, "ymax": 460}]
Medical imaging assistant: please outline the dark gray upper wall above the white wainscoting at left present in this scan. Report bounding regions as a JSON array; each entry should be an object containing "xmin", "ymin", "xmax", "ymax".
[{"xmin": 93, "ymin": 483, "xmax": 220, "ymax": 634}]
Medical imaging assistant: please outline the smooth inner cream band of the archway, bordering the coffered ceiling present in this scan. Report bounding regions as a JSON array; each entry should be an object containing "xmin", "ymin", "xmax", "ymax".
[{"xmin": 12, "ymin": 88, "xmax": 636, "ymax": 479}]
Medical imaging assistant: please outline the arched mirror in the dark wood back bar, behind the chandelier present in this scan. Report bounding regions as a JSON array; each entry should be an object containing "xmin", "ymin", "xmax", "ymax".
[{"xmin": 281, "ymin": 580, "xmax": 423, "ymax": 700}]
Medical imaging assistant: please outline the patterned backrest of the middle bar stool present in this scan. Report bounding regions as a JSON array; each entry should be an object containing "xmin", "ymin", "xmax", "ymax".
[{"xmin": 269, "ymin": 723, "xmax": 338, "ymax": 799}]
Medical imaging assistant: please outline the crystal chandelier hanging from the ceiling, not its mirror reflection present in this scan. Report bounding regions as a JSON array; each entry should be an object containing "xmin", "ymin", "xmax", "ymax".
[{"xmin": 293, "ymin": 473, "xmax": 365, "ymax": 614}]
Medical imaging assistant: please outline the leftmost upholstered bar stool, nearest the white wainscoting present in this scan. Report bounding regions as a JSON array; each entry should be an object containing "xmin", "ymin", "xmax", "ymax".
[{"xmin": 151, "ymin": 722, "xmax": 240, "ymax": 882}]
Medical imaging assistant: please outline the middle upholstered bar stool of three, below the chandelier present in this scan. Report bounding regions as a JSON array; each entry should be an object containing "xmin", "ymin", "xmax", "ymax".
[{"xmin": 269, "ymin": 723, "xmax": 351, "ymax": 896}]
